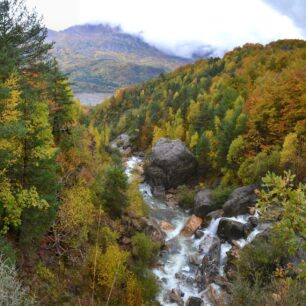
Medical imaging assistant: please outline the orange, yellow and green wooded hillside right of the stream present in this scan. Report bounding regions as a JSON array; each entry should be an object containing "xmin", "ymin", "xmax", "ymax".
[{"xmin": 94, "ymin": 40, "xmax": 306, "ymax": 185}]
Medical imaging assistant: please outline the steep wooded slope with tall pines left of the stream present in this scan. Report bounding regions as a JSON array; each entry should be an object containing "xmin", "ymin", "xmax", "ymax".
[{"xmin": 0, "ymin": 0, "xmax": 158, "ymax": 306}]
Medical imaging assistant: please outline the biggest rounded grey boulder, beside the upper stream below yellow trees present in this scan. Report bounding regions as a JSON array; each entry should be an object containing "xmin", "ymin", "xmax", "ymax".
[{"xmin": 145, "ymin": 138, "xmax": 197, "ymax": 189}]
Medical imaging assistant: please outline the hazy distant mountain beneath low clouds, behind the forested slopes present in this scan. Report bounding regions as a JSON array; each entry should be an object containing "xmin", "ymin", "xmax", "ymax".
[{"xmin": 48, "ymin": 24, "xmax": 190, "ymax": 93}]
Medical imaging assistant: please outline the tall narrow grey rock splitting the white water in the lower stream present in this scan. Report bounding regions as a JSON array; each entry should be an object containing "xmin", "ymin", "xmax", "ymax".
[{"xmin": 196, "ymin": 237, "xmax": 221, "ymax": 290}]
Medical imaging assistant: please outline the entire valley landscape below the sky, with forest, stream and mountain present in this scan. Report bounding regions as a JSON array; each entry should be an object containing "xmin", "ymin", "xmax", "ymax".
[{"xmin": 0, "ymin": 0, "xmax": 306, "ymax": 306}]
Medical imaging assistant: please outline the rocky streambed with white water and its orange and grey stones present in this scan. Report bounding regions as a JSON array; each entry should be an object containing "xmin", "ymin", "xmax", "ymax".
[{"xmin": 126, "ymin": 156, "xmax": 263, "ymax": 306}]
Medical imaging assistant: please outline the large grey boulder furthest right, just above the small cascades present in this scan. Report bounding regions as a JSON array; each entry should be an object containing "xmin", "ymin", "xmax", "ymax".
[{"xmin": 223, "ymin": 184, "xmax": 258, "ymax": 217}]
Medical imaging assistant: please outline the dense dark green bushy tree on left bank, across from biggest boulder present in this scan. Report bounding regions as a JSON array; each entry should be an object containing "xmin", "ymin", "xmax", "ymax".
[{"xmin": 93, "ymin": 165, "xmax": 128, "ymax": 218}]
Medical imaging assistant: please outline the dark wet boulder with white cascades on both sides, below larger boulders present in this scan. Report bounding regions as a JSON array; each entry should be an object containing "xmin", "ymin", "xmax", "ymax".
[{"xmin": 217, "ymin": 218, "xmax": 253, "ymax": 242}]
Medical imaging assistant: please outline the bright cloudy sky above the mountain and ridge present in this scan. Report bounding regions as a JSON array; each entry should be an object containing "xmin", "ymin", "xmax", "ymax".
[{"xmin": 26, "ymin": 0, "xmax": 306, "ymax": 57}]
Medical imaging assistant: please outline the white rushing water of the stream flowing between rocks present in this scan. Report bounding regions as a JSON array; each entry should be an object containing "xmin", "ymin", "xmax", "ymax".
[{"xmin": 126, "ymin": 156, "xmax": 261, "ymax": 306}]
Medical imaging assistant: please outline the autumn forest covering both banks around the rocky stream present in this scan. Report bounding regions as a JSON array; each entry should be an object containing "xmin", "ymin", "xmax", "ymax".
[{"xmin": 0, "ymin": 0, "xmax": 306, "ymax": 306}]
